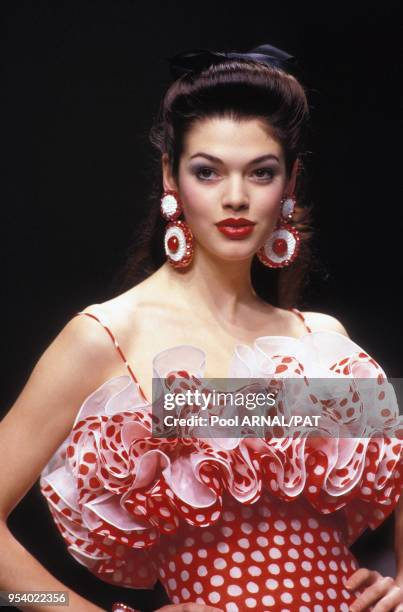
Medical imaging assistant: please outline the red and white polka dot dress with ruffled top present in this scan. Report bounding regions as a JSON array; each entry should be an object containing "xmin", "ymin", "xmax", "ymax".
[{"xmin": 40, "ymin": 311, "xmax": 403, "ymax": 612}]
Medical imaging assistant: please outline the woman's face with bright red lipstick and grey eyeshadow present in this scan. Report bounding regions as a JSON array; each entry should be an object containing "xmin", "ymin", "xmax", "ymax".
[{"xmin": 163, "ymin": 118, "xmax": 297, "ymax": 260}]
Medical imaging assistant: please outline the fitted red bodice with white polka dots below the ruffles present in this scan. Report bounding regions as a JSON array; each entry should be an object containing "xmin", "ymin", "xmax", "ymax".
[{"xmin": 158, "ymin": 494, "xmax": 366, "ymax": 612}]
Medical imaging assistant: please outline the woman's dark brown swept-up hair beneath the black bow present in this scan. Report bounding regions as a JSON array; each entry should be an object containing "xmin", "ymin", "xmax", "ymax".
[{"xmin": 115, "ymin": 59, "xmax": 318, "ymax": 308}]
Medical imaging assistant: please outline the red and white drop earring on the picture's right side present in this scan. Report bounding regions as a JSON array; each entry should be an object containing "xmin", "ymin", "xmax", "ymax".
[{"xmin": 256, "ymin": 196, "xmax": 300, "ymax": 268}]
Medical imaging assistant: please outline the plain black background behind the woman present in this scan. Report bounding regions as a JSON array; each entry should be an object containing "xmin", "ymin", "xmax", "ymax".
[{"xmin": 0, "ymin": 0, "xmax": 403, "ymax": 610}]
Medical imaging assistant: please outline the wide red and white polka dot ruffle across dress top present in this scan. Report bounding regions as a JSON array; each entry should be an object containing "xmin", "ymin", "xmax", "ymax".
[{"xmin": 40, "ymin": 332, "xmax": 403, "ymax": 589}]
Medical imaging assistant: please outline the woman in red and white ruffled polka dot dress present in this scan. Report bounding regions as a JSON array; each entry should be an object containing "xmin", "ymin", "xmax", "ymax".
[{"xmin": 0, "ymin": 45, "xmax": 403, "ymax": 612}]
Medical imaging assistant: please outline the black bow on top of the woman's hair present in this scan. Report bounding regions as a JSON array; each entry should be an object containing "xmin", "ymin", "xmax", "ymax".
[{"xmin": 167, "ymin": 44, "xmax": 294, "ymax": 79}]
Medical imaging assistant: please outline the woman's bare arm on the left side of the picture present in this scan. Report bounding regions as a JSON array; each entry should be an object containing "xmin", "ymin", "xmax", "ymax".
[{"xmin": 0, "ymin": 317, "xmax": 124, "ymax": 612}]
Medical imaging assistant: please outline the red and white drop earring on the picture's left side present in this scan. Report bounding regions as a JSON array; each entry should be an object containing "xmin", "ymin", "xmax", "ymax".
[{"xmin": 161, "ymin": 190, "xmax": 194, "ymax": 268}]
